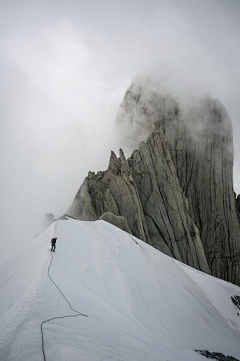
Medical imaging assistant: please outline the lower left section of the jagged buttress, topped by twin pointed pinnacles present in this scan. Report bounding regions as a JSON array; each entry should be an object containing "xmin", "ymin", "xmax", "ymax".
[{"xmin": 69, "ymin": 150, "xmax": 150, "ymax": 243}]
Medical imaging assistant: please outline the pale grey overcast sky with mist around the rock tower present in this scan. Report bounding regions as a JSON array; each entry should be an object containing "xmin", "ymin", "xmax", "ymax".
[{"xmin": 0, "ymin": 0, "xmax": 240, "ymax": 262}]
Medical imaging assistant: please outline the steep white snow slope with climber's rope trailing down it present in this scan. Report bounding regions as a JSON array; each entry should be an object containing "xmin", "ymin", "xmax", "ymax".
[{"xmin": 0, "ymin": 220, "xmax": 240, "ymax": 361}]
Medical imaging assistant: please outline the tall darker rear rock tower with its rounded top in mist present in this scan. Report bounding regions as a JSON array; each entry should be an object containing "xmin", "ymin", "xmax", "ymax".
[{"xmin": 114, "ymin": 84, "xmax": 240, "ymax": 284}]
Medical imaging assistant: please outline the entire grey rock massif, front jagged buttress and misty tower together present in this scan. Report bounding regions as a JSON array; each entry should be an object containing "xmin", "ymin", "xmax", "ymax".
[{"xmin": 68, "ymin": 80, "xmax": 240, "ymax": 285}]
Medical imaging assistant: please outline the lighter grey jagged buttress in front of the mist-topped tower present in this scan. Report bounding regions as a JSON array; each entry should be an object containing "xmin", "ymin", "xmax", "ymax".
[{"xmin": 68, "ymin": 132, "xmax": 209, "ymax": 273}]
